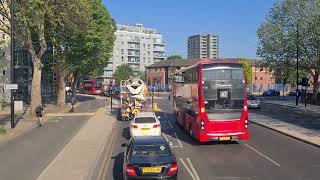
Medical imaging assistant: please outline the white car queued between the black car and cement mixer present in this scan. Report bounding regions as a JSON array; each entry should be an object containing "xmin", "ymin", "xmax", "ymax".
[{"xmin": 130, "ymin": 112, "xmax": 161, "ymax": 137}]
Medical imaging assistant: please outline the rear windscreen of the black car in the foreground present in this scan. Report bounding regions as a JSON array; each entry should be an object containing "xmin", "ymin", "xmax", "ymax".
[{"xmin": 131, "ymin": 144, "xmax": 170, "ymax": 156}]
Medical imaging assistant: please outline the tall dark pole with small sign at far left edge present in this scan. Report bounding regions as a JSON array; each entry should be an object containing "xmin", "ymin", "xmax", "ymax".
[{"xmin": 10, "ymin": 0, "xmax": 15, "ymax": 128}]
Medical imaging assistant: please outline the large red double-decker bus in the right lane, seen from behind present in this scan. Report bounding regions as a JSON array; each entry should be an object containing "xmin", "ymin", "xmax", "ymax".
[{"xmin": 174, "ymin": 60, "xmax": 249, "ymax": 142}]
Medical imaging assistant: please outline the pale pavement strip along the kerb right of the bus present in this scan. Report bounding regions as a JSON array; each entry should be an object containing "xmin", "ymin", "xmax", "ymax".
[{"xmin": 249, "ymin": 113, "xmax": 320, "ymax": 147}]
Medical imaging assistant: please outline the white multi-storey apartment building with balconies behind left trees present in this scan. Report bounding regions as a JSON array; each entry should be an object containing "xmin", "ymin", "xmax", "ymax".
[{"xmin": 101, "ymin": 24, "xmax": 166, "ymax": 83}]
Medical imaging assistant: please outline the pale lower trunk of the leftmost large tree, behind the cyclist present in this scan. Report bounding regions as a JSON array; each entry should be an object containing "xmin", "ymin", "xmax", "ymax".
[{"xmin": 31, "ymin": 59, "xmax": 42, "ymax": 114}]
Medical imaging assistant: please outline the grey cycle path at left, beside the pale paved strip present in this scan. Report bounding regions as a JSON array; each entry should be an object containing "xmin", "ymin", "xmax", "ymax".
[{"xmin": 0, "ymin": 97, "xmax": 106, "ymax": 180}]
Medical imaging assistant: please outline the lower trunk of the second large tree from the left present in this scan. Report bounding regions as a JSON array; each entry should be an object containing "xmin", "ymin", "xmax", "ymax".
[{"xmin": 56, "ymin": 70, "xmax": 66, "ymax": 108}]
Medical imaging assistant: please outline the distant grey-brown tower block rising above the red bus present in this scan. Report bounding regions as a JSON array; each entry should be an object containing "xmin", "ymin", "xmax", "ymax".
[{"xmin": 188, "ymin": 34, "xmax": 219, "ymax": 59}]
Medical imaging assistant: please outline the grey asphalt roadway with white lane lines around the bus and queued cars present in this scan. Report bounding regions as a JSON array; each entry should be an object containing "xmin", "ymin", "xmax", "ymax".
[{"xmin": 106, "ymin": 96, "xmax": 320, "ymax": 180}]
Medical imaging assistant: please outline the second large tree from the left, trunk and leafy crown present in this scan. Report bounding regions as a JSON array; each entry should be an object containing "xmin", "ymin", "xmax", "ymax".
[{"xmin": 45, "ymin": 0, "xmax": 91, "ymax": 108}]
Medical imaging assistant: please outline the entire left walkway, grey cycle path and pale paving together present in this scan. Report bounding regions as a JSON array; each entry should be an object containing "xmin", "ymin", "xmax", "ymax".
[{"xmin": 0, "ymin": 97, "xmax": 112, "ymax": 180}]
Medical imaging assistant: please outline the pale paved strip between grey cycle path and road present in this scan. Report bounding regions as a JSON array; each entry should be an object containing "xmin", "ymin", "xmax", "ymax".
[{"xmin": 38, "ymin": 108, "xmax": 116, "ymax": 180}]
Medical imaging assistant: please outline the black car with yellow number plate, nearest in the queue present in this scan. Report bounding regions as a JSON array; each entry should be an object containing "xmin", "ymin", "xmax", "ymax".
[{"xmin": 123, "ymin": 136, "xmax": 178, "ymax": 180}]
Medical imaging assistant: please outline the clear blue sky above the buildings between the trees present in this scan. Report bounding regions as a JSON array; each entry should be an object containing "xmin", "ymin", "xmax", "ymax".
[{"xmin": 103, "ymin": 0, "xmax": 274, "ymax": 58}]
